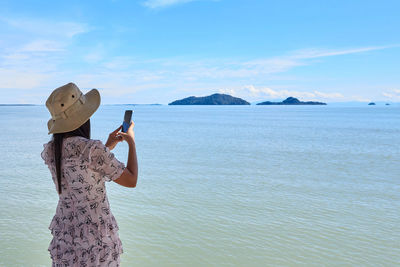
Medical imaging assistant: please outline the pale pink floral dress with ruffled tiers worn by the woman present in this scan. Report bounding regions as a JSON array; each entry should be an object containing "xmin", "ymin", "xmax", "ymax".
[{"xmin": 41, "ymin": 136, "xmax": 125, "ymax": 266}]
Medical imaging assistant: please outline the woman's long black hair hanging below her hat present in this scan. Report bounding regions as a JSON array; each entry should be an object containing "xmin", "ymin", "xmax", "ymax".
[{"xmin": 53, "ymin": 119, "xmax": 90, "ymax": 194}]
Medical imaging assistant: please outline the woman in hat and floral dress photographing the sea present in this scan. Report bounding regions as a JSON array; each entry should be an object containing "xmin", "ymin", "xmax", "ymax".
[{"xmin": 41, "ymin": 83, "xmax": 138, "ymax": 266}]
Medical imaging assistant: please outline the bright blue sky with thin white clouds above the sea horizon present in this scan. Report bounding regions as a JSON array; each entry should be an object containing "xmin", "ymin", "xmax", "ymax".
[{"xmin": 0, "ymin": 0, "xmax": 400, "ymax": 104}]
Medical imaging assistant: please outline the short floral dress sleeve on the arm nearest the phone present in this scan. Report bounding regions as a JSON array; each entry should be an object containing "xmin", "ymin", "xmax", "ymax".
[{"xmin": 89, "ymin": 140, "xmax": 125, "ymax": 182}]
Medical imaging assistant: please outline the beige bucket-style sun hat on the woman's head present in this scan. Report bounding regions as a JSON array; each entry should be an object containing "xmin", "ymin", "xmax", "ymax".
[{"xmin": 46, "ymin": 83, "xmax": 100, "ymax": 134}]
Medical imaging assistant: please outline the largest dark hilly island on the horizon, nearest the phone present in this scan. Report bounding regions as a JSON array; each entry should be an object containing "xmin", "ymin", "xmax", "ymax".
[{"xmin": 168, "ymin": 94, "xmax": 250, "ymax": 105}]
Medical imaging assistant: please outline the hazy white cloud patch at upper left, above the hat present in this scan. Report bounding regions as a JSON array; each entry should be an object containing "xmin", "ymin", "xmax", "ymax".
[{"xmin": 0, "ymin": 17, "xmax": 89, "ymax": 94}]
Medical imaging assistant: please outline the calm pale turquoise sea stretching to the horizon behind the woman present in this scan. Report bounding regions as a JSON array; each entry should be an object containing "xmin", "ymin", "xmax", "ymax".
[{"xmin": 0, "ymin": 105, "xmax": 400, "ymax": 266}]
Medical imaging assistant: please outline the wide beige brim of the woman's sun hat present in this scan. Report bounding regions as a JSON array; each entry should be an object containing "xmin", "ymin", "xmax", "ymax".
[{"xmin": 47, "ymin": 89, "xmax": 100, "ymax": 134}]
